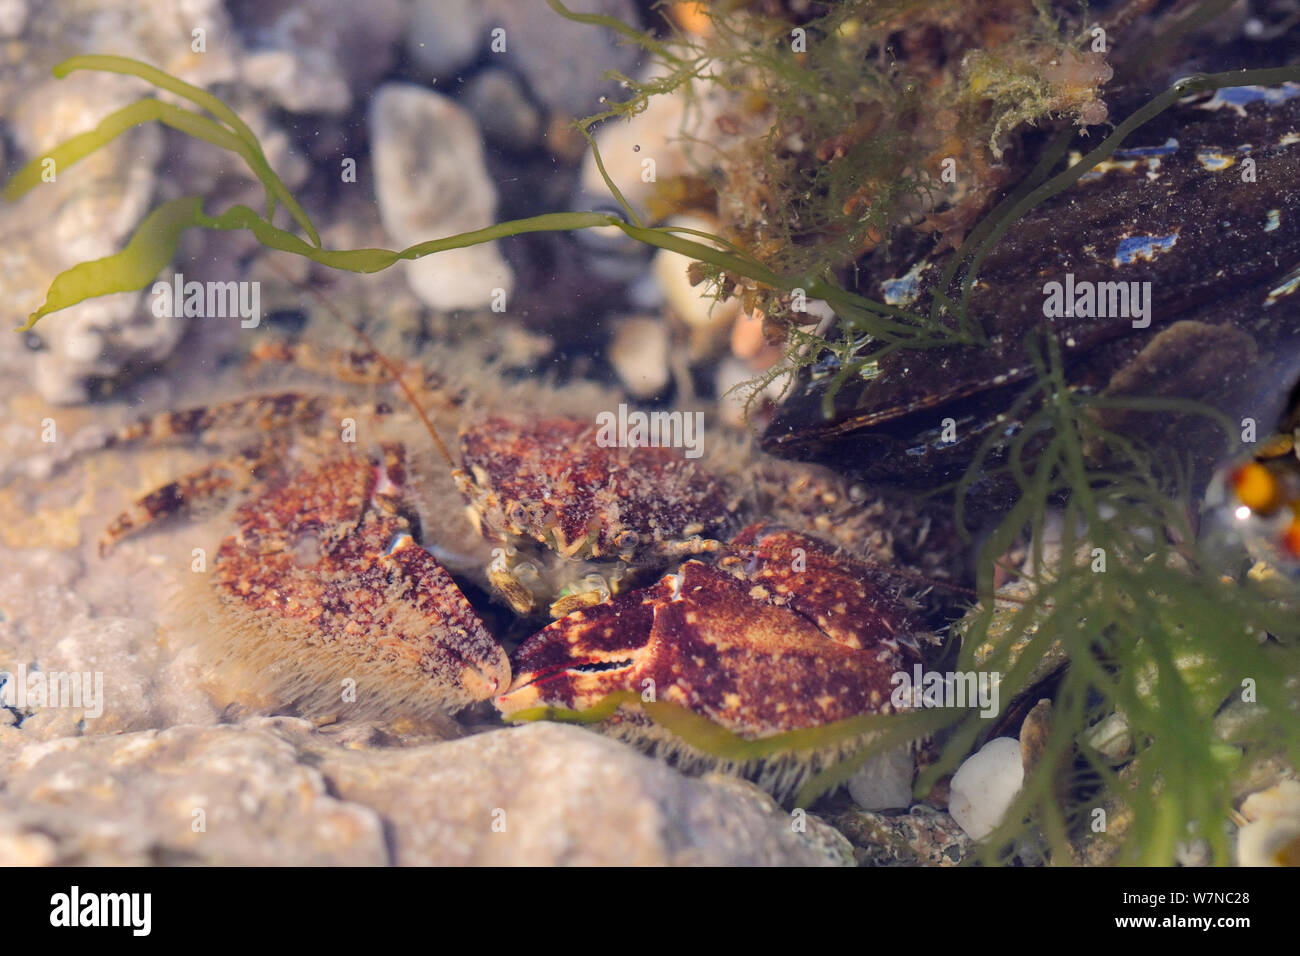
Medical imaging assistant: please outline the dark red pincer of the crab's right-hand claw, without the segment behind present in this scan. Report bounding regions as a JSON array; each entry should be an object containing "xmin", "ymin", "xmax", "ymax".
[{"xmin": 497, "ymin": 561, "xmax": 910, "ymax": 737}]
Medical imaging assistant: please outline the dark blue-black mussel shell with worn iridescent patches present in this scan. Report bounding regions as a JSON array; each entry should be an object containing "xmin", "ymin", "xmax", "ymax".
[{"xmin": 762, "ymin": 85, "xmax": 1300, "ymax": 488}]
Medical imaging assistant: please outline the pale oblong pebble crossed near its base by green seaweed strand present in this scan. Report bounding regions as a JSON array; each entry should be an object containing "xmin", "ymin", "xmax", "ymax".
[{"xmin": 371, "ymin": 83, "xmax": 514, "ymax": 310}]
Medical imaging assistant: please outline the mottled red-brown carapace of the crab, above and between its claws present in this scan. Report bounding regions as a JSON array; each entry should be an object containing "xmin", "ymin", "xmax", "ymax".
[{"xmin": 460, "ymin": 415, "xmax": 728, "ymax": 561}]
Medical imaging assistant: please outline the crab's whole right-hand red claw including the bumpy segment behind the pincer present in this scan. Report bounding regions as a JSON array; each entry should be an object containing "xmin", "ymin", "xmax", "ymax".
[{"xmin": 497, "ymin": 531, "xmax": 919, "ymax": 737}]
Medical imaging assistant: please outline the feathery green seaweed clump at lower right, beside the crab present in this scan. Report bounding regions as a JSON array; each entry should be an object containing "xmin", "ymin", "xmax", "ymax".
[{"xmin": 918, "ymin": 339, "xmax": 1300, "ymax": 865}]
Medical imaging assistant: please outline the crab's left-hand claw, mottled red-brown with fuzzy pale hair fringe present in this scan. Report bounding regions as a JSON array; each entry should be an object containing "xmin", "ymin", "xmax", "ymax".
[{"xmin": 213, "ymin": 451, "xmax": 510, "ymax": 713}]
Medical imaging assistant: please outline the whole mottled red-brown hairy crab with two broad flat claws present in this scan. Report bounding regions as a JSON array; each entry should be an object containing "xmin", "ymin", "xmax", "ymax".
[{"xmin": 89, "ymin": 366, "xmax": 937, "ymax": 785}]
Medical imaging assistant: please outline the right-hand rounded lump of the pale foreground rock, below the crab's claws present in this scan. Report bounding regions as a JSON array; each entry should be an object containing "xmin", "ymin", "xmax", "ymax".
[{"xmin": 320, "ymin": 723, "xmax": 837, "ymax": 866}]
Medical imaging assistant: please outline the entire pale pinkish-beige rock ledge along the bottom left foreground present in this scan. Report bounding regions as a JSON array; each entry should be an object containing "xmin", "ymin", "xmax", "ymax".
[{"xmin": 0, "ymin": 718, "xmax": 853, "ymax": 866}]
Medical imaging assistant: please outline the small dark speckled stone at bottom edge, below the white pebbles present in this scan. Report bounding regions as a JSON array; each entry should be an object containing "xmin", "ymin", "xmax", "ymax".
[{"xmin": 832, "ymin": 804, "xmax": 975, "ymax": 866}]
